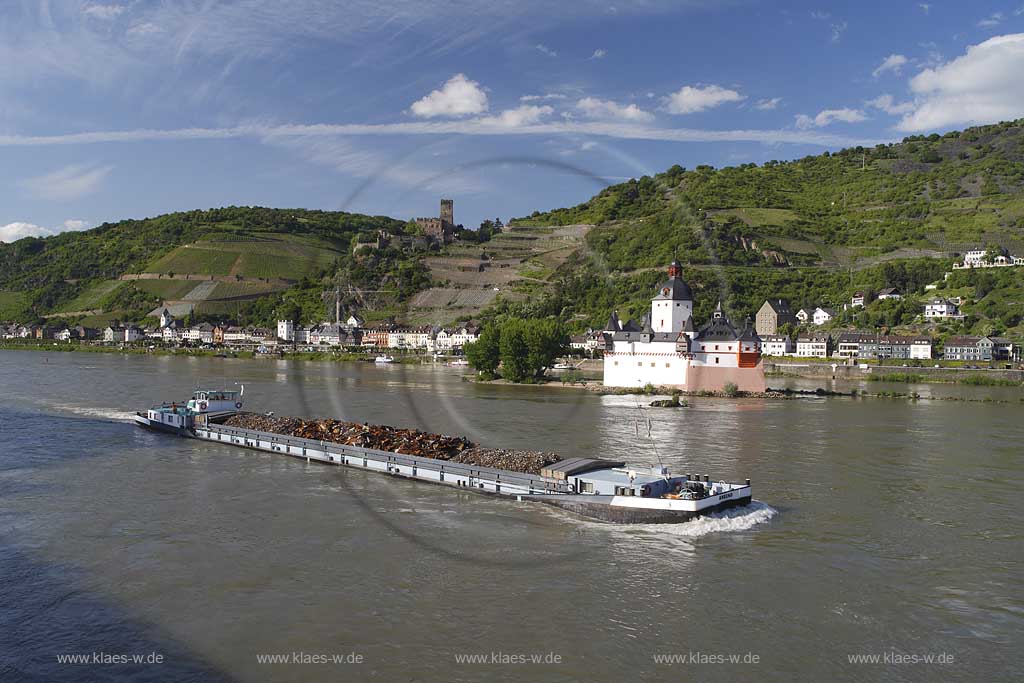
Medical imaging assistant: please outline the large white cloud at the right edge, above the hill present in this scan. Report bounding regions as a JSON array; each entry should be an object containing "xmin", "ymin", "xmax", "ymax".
[{"xmin": 899, "ymin": 33, "xmax": 1024, "ymax": 131}]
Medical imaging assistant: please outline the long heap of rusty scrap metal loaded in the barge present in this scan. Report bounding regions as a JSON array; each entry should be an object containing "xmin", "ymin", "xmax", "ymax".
[{"xmin": 224, "ymin": 413, "xmax": 561, "ymax": 474}]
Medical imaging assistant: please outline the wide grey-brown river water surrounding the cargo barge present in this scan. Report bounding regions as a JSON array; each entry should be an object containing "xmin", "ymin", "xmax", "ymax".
[{"xmin": 0, "ymin": 351, "xmax": 1024, "ymax": 683}]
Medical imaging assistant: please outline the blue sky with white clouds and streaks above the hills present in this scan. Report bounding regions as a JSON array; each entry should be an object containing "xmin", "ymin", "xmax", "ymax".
[{"xmin": 0, "ymin": 0, "xmax": 1024, "ymax": 242}]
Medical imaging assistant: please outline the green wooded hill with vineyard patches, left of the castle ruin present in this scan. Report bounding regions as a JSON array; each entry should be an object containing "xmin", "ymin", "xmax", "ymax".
[{"xmin": 0, "ymin": 207, "xmax": 406, "ymax": 325}]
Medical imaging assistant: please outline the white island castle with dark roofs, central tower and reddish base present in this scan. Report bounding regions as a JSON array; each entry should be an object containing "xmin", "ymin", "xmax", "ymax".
[{"xmin": 604, "ymin": 261, "xmax": 766, "ymax": 392}]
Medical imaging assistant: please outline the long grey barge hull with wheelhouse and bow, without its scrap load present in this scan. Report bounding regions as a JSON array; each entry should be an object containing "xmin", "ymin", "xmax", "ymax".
[{"xmin": 135, "ymin": 390, "xmax": 752, "ymax": 524}]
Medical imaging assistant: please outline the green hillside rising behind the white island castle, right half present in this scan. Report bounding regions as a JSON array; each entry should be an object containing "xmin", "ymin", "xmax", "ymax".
[{"xmin": 512, "ymin": 121, "xmax": 1024, "ymax": 334}]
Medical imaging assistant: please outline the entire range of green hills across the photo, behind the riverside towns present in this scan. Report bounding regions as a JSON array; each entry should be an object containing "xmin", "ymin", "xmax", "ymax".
[{"xmin": 6, "ymin": 121, "xmax": 1024, "ymax": 335}]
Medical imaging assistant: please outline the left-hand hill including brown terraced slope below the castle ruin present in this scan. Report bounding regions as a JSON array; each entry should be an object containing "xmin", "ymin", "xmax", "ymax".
[{"xmin": 0, "ymin": 207, "xmax": 586, "ymax": 327}]
